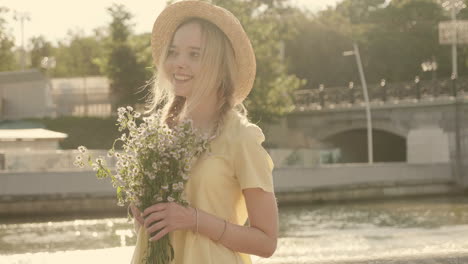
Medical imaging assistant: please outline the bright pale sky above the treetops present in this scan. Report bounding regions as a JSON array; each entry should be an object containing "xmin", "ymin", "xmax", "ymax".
[{"xmin": 0, "ymin": 0, "xmax": 341, "ymax": 45}]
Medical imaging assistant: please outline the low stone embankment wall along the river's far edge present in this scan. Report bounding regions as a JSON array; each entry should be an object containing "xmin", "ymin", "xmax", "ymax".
[{"xmin": 0, "ymin": 163, "xmax": 456, "ymax": 216}]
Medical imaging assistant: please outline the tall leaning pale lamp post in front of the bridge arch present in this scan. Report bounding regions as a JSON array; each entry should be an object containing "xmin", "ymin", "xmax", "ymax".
[{"xmin": 343, "ymin": 43, "xmax": 374, "ymax": 164}]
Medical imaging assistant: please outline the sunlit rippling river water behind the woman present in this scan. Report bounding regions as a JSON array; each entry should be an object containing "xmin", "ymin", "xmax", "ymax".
[{"xmin": 0, "ymin": 197, "xmax": 468, "ymax": 264}]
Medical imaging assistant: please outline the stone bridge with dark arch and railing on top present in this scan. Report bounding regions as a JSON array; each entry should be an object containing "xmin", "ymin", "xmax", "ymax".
[{"xmin": 266, "ymin": 75, "xmax": 468, "ymax": 188}]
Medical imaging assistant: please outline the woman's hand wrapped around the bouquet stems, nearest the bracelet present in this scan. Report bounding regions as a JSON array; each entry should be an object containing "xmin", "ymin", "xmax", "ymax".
[{"xmin": 143, "ymin": 202, "xmax": 196, "ymax": 241}]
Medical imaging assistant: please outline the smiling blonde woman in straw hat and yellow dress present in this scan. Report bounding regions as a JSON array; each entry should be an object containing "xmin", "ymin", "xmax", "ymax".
[{"xmin": 130, "ymin": 1, "xmax": 278, "ymax": 264}]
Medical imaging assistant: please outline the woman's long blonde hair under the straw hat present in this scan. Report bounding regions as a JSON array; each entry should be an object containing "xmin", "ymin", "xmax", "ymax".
[{"xmin": 144, "ymin": 18, "xmax": 247, "ymax": 132}]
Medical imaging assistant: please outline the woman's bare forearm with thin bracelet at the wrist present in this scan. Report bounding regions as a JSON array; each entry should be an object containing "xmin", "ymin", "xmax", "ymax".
[{"xmin": 193, "ymin": 206, "xmax": 276, "ymax": 258}]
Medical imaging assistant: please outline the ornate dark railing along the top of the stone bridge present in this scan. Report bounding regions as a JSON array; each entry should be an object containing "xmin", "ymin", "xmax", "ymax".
[{"xmin": 294, "ymin": 77, "xmax": 468, "ymax": 110}]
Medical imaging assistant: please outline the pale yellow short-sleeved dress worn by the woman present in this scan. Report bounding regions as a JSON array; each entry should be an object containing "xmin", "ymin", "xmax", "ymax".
[{"xmin": 132, "ymin": 110, "xmax": 274, "ymax": 264}]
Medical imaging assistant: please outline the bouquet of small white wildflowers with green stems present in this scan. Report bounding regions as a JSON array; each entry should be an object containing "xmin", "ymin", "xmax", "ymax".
[{"xmin": 74, "ymin": 106, "xmax": 208, "ymax": 264}]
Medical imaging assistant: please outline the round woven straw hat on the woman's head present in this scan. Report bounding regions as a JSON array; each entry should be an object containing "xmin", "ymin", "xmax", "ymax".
[{"xmin": 151, "ymin": 1, "xmax": 256, "ymax": 104}]
